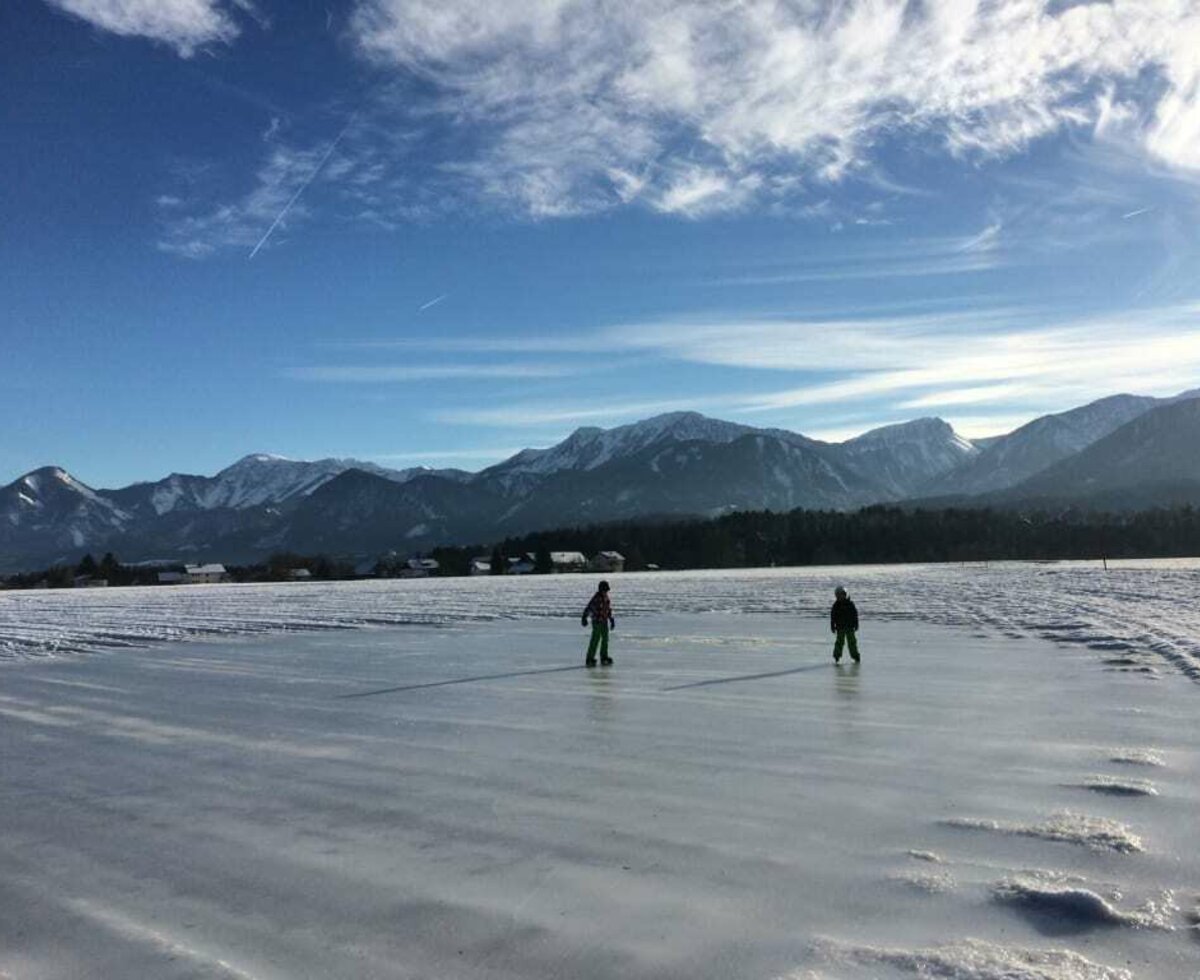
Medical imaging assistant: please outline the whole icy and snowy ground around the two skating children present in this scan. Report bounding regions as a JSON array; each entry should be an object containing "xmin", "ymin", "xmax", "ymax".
[{"xmin": 0, "ymin": 563, "xmax": 1200, "ymax": 980}]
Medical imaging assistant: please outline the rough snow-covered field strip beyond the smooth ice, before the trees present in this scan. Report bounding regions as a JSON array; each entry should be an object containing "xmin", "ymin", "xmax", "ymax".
[{"xmin": 0, "ymin": 559, "xmax": 1200, "ymax": 680}]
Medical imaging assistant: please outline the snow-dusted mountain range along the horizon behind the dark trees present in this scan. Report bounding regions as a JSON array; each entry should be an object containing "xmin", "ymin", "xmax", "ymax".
[{"xmin": 0, "ymin": 391, "xmax": 1200, "ymax": 571}]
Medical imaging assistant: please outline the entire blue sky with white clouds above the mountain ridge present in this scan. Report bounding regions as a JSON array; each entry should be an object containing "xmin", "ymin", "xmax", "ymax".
[{"xmin": 0, "ymin": 0, "xmax": 1200, "ymax": 486}]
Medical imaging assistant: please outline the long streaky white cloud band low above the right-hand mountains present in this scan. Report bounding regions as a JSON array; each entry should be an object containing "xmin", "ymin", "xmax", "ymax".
[{"xmin": 427, "ymin": 303, "xmax": 1200, "ymax": 434}]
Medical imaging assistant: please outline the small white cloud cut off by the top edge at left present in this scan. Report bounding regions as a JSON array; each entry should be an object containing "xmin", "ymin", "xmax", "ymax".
[{"xmin": 46, "ymin": 0, "xmax": 252, "ymax": 58}]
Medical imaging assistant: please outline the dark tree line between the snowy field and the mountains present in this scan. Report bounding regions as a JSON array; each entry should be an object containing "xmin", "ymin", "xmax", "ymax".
[{"xmin": 4, "ymin": 505, "xmax": 1200, "ymax": 589}]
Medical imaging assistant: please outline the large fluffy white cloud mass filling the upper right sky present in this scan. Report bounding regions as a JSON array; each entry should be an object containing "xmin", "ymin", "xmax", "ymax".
[{"xmin": 350, "ymin": 0, "xmax": 1200, "ymax": 216}]
